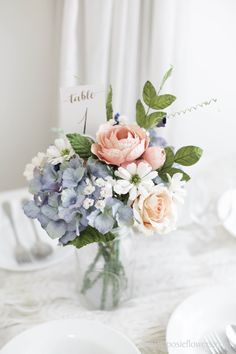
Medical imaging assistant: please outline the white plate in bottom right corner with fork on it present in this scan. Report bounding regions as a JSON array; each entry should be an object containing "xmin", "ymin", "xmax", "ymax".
[{"xmin": 166, "ymin": 287, "xmax": 236, "ymax": 354}]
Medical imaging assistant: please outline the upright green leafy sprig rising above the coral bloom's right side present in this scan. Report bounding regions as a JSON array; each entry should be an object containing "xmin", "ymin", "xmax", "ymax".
[{"xmin": 136, "ymin": 67, "xmax": 176, "ymax": 129}]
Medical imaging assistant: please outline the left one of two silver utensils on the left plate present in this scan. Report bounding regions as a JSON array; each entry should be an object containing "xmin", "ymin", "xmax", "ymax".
[{"xmin": 2, "ymin": 202, "xmax": 32, "ymax": 264}]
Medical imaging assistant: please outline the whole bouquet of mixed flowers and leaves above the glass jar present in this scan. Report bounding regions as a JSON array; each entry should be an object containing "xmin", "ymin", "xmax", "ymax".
[{"xmin": 24, "ymin": 69, "xmax": 202, "ymax": 308}]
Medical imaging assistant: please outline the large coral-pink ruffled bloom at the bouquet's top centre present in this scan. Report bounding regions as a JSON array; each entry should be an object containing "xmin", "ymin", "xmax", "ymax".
[{"xmin": 91, "ymin": 124, "xmax": 149, "ymax": 166}]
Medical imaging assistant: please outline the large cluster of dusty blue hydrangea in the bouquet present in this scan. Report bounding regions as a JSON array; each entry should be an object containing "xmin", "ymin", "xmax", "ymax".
[{"xmin": 24, "ymin": 156, "xmax": 129, "ymax": 244}]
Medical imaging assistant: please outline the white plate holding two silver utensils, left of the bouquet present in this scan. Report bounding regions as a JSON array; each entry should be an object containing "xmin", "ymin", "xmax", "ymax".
[{"xmin": 0, "ymin": 189, "xmax": 74, "ymax": 272}]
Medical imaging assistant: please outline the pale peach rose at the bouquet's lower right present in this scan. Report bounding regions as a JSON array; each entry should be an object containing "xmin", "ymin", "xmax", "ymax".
[{"xmin": 133, "ymin": 185, "xmax": 176, "ymax": 234}]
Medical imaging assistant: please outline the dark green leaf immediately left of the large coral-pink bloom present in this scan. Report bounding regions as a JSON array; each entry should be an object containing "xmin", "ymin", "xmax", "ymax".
[{"xmin": 66, "ymin": 134, "xmax": 93, "ymax": 159}]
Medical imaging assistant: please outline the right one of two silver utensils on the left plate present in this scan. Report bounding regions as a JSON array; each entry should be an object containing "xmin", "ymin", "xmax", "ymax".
[{"xmin": 21, "ymin": 199, "xmax": 53, "ymax": 259}]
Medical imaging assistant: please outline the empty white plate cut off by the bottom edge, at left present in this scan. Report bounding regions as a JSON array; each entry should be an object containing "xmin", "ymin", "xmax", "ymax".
[{"xmin": 0, "ymin": 320, "xmax": 140, "ymax": 354}]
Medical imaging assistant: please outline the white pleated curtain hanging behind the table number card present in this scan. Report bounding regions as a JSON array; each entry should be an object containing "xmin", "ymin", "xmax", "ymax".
[{"xmin": 60, "ymin": 0, "xmax": 174, "ymax": 124}]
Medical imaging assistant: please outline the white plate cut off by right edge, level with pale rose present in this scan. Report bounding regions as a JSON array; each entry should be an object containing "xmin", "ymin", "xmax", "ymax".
[{"xmin": 218, "ymin": 189, "xmax": 236, "ymax": 237}]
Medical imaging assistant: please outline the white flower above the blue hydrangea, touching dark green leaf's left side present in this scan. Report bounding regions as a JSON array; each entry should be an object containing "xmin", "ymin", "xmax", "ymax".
[{"xmin": 47, "ymin": 138, "xmax": 75, "ymax": 165}]
